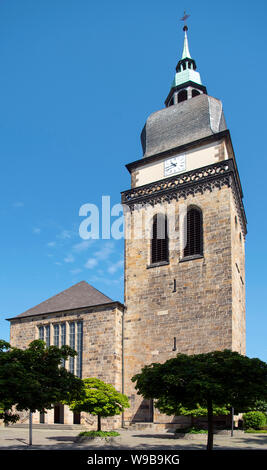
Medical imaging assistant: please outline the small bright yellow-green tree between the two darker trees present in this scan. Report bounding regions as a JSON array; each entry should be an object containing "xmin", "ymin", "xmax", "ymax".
[{"xmin": 68, "ymin": 377, "xmax": 130, "ymax": 431}]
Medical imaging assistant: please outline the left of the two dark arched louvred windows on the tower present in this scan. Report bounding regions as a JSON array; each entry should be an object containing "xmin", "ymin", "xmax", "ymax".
[{"xmin": 151, "ymin": 214, "xmax": 169, "ymax": 264}]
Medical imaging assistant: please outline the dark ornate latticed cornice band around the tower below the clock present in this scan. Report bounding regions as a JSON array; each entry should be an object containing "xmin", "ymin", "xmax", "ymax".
[{"xmin": 121, "ymin": 159, "xmax": 247, "ymax": 235}]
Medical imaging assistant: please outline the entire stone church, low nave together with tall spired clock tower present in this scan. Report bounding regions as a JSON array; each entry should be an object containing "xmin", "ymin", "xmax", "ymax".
[{"xmin": 9, "ymin": 26, "xmax": 246, "ymax": 428}]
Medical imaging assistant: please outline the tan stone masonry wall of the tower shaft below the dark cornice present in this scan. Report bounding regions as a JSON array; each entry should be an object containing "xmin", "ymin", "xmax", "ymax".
[{"xmin": 124, "ymin": 186, "xmax": 244, "ymax": 422}]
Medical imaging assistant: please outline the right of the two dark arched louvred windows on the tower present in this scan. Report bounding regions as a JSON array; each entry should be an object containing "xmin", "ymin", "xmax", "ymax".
[{"xmin": 184, "ymin": 207, "xmax": 203, "ymax": 256}]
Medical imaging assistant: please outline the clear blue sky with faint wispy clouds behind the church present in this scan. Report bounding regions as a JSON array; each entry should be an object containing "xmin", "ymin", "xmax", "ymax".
[{"xmin": 0, "ymin": 0, "xmax": 267, "ymax": 361}]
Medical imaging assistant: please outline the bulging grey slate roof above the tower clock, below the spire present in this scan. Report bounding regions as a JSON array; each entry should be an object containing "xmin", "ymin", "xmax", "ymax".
[{"xmin": 141, "ymin": 94, "xmax": 227, "ymax": 157}]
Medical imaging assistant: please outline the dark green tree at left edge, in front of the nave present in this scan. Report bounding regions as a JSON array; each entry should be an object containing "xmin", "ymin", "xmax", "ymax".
[{"xmin": 0, "ymin": 340, "xmax": 83, "ymax": 443}]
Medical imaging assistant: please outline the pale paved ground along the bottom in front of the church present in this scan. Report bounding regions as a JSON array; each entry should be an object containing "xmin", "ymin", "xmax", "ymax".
[{"xmin": 0, "ymin": 427, "xmax": 267, "ymax": 450}]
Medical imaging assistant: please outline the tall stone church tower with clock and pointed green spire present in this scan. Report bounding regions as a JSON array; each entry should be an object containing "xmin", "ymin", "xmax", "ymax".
[{"xmin": 122, "ymin": 26, "xmax": 246, "ymax": 423}]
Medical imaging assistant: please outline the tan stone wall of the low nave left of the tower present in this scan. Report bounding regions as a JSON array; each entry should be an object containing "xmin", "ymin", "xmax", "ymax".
[{"xmin": 10, "ymin": 306, "xmax": 122, "ymax": 429}]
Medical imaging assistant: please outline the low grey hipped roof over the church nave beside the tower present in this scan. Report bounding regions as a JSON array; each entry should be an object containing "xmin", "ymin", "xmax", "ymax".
[{"xmin": 9, "ymin": 281, "xmax": 117, "ymax": 320}]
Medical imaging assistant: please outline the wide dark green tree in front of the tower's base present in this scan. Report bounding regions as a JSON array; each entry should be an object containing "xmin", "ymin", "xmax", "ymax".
[{"xmin": 132, "ymin": 349, "xmax": 267, "ymax": 450}]
